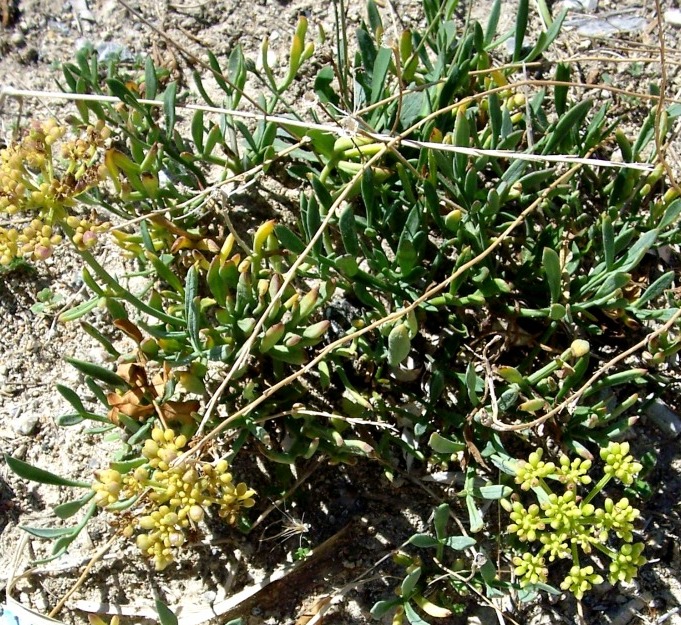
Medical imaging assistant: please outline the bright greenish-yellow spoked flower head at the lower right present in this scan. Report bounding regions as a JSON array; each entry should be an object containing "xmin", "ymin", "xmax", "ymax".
[{"xmin": 502, "ymin": 443, "xmax": 646, "ymax": 599}]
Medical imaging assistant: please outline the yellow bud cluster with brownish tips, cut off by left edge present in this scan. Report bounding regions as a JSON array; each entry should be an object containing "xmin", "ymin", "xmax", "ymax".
[{"xmin": 0, "ymin": 119, "xmax": 110, "ymax": 265}]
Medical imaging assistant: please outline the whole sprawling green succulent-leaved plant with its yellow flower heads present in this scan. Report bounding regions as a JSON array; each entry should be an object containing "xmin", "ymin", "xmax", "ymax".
[{"xmin": 0, "ymin": 0, "xmax": 681, "ymax": 623}]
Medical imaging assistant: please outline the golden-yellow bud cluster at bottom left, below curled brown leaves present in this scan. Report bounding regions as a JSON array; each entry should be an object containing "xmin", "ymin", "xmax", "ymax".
[{"xmin": 92, "ymin": 428, "xmax": 255, "ymax": 571}]
